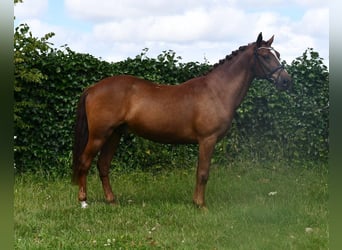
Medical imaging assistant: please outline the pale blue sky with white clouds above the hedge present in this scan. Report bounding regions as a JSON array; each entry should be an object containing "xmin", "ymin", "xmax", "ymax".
[{"xmin": 14, "ymin": 0, "xmax": 329, "ymax": 66}]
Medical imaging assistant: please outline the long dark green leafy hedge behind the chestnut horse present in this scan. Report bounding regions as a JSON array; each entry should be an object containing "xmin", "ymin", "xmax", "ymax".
[{"xmin": 14, "ymin": 25, "xmax": 329, "ymax": 174}]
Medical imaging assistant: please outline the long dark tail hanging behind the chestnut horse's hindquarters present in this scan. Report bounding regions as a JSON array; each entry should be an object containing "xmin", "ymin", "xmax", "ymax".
[{"xmin": 72, "ymin": 90, "xmax": 88, "ymax": 185}]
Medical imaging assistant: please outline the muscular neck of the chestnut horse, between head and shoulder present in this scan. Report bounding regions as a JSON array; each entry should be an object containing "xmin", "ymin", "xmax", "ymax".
[{"xmin": 207, "ymin": 49, "xmax": 254, "ymax": 108}]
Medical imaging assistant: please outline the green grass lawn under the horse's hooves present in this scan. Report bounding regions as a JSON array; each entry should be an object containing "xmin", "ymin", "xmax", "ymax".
[{"xmin": 14, "ymin": 162, "xmax": 328, "ymax": 250}]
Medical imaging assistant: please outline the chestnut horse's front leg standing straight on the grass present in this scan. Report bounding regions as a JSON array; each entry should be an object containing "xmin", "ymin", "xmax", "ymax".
[{"xmin": 193, "ymin": 138, "xmax": 216, "ymax": 208}]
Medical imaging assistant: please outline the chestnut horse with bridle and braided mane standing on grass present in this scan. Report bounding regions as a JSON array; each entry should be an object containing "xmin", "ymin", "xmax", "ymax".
[{"xmin": 73, "ymin": 33, "xmax": 291, "ymax": 208}]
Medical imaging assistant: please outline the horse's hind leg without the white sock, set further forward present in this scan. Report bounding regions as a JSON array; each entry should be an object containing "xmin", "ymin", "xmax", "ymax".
[{"xmin": 97, "ymin": 132, "xmax": 121, "ymax": 204}]
